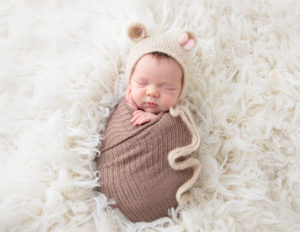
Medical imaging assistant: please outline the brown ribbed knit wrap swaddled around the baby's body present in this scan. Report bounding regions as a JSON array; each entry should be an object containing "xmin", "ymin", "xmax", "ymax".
[{"xmin": 97, "ymin": 99, "xmax": 192, "ymax": 222}]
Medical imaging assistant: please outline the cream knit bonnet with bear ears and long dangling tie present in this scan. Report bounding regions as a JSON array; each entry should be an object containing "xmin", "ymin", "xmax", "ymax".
[{"xmin": 125, "ymin": 23, "xmax": 200, "ymax": 205}]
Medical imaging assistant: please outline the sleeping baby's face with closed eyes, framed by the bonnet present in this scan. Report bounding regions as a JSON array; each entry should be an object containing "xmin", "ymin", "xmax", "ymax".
[{"xmin": 130, "ymin": 54, "xmax": 183, "ymax": 114}]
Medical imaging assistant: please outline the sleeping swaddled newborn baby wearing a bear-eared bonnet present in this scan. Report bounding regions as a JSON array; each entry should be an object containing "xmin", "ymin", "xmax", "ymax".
[{"xmin": 97, "ymin": 24, "xmax": 200, "ymax": 222}]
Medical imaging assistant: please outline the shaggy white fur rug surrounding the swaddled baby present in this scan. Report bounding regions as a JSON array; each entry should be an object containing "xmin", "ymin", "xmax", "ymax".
[{"xmin": 0, "ymin": 0, "xmax": 300, "ymax": 232}]
